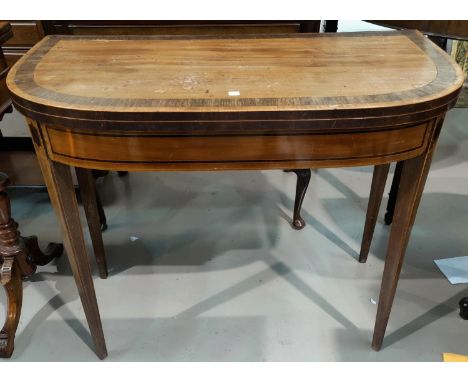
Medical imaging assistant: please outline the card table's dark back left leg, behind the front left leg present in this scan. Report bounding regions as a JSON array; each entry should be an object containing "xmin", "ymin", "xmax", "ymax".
[{"xmin": 75, "ymin": 167, "xmax": 108, "ymax": 279}]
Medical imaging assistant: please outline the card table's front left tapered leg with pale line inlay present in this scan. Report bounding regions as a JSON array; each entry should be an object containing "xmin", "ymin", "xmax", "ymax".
[{"xmin": 28, "ymin": 120, "xmax": 107, "ymax": 359}]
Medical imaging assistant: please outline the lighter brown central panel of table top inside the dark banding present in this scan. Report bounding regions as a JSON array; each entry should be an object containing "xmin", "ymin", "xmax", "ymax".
[{"xmin": 34, "ymin": 36, "xmax": 437, "ymax": 100}]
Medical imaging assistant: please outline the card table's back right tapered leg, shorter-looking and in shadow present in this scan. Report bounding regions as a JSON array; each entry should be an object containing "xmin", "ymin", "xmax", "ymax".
[{"xmin": 359, "ymin": 163, "xmax": 390, "ymax": 263}]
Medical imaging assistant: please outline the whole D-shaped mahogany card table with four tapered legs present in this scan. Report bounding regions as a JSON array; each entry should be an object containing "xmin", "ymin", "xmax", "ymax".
[{"xmin": 3, "ymin": 31, "xmax": 464, "ymax": 358}]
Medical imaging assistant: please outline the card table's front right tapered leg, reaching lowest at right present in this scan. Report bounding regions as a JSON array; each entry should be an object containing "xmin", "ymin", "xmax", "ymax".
[{"xmin": 372, "ymin": 119, "xmax": 442, "ymax": 350}]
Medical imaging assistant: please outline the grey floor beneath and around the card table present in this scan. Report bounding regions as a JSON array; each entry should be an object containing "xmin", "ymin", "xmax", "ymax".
[{"xmin": 0, "ymin": 109, "xmax": 468, "ymax": 361}]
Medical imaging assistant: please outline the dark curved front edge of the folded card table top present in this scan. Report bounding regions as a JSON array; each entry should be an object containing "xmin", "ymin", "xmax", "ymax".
[{"xmin": 15, "ymin": 97, "xmax": 456, "ymax": 135}]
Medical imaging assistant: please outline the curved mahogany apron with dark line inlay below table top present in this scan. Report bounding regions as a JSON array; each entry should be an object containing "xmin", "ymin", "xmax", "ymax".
[{"xmin": 32, "ymin": 121, "xmax": 433, "ymax": 171}]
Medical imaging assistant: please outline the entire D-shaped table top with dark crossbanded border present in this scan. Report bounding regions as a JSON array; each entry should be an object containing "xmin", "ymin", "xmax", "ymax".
[{"xmin": 8, "ymin": 31, "xmax": 463, "ymax": 117}]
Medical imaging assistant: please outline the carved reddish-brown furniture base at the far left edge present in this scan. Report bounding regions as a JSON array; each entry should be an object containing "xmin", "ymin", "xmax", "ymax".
[{"xmin": 0, "ymin": 173, "xmax": 63, "ymax": 358}]
